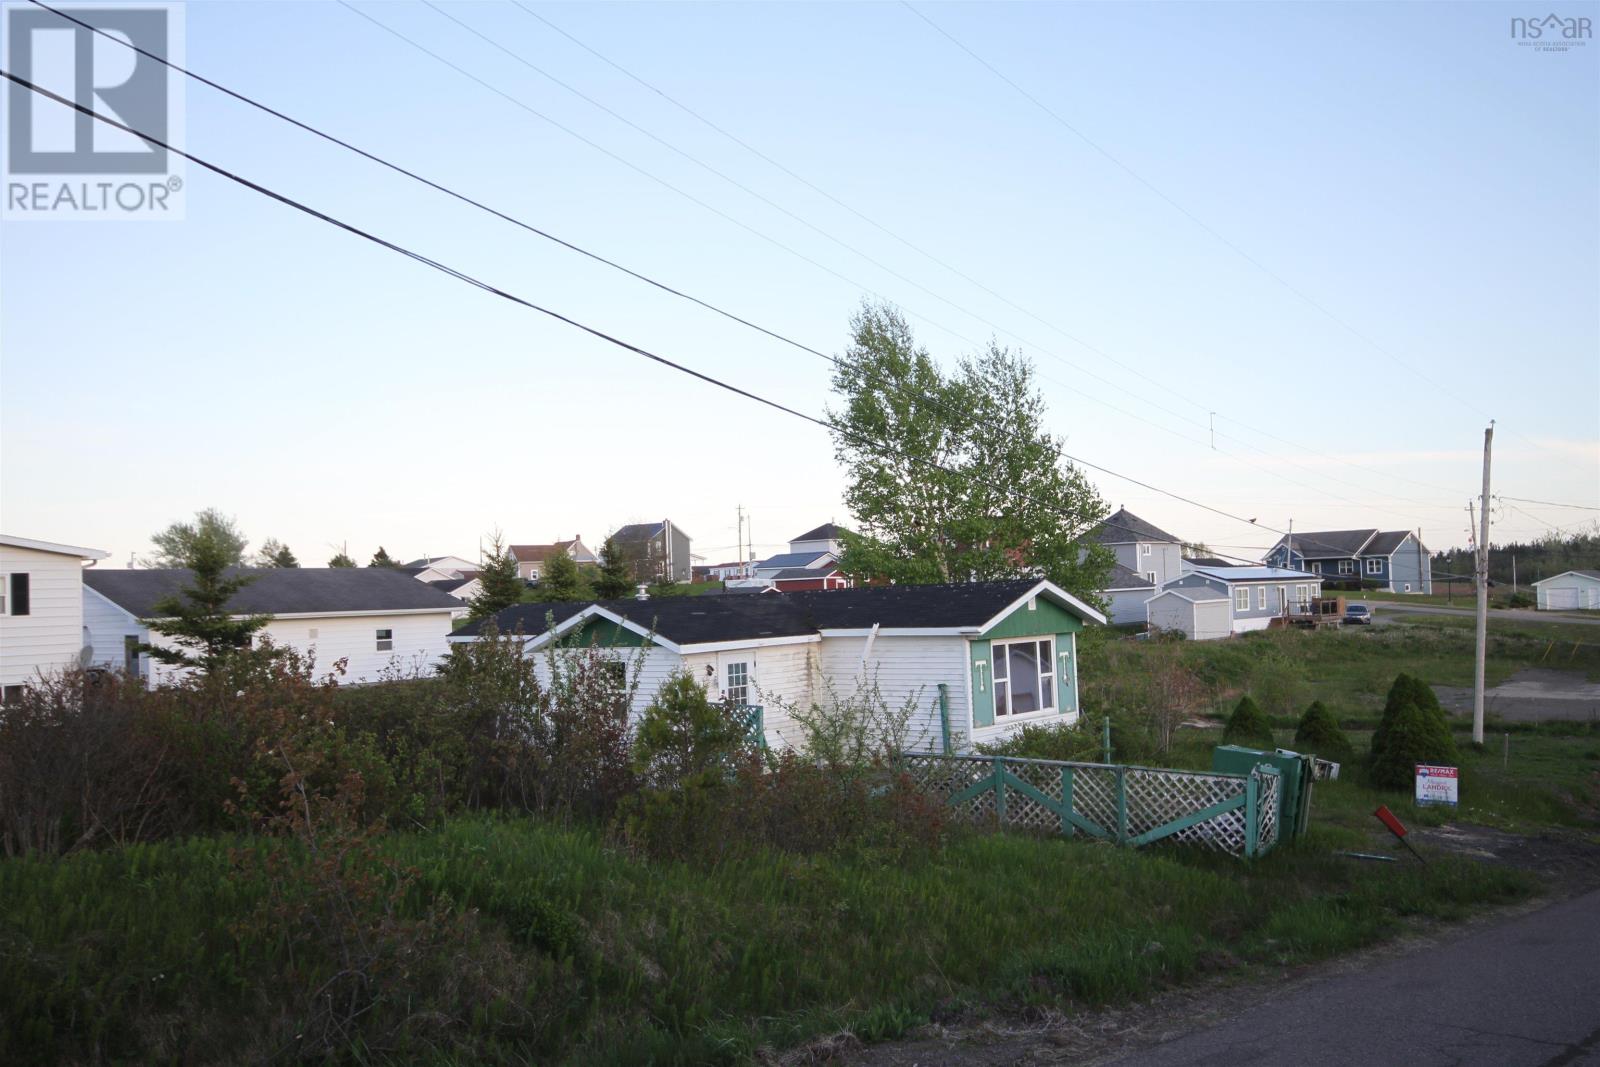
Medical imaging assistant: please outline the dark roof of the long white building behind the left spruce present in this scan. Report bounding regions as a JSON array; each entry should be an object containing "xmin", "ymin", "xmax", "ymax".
[{"xmin": 83, "ymin": 566, "xmax": 461, "ymax": 619}]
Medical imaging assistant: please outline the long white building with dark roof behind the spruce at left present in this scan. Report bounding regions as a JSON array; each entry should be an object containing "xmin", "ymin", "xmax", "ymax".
[{"xmin": 82, "ymin": 566, "xmax": 462, "ymax": 685}]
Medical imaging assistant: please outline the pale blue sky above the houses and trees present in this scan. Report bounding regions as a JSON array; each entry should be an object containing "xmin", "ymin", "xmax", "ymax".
[{"xmin": 0, "ymin": 0, "xmax": 1600, "ymax": 565}]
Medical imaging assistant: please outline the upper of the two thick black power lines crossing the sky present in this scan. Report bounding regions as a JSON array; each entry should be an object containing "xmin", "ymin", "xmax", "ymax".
[{"xmin": 32, "ymin": 0, "xmax": 1452, "ymax": 531}]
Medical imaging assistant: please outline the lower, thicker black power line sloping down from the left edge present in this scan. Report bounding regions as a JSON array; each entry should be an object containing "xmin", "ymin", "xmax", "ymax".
[{"xmin": 0, "ymin": 69, "xmax": 1312, "ymax": 566}]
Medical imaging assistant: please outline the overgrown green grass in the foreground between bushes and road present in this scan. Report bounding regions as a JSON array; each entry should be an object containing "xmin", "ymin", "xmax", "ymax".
[{"xmin": 0, "ymin": 817, "xmax": 1531, "ymax": 1064}]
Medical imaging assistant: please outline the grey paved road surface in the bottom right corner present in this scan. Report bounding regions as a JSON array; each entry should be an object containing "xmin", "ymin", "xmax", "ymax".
[{"xmin": 1115, "ymin": 891, "xmax": 1600, "ymax": 1067}]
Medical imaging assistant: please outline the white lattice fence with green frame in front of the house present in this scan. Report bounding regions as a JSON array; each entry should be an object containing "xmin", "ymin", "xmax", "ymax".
[{"xmin": 902, "ymin": 755, "xmax": 1282, "ymax": 856}]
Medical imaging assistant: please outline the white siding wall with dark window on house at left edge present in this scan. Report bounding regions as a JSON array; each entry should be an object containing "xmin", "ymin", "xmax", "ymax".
[{"xmin": 0, "ymin": 545, "xmax": 83, "ymax": 685}]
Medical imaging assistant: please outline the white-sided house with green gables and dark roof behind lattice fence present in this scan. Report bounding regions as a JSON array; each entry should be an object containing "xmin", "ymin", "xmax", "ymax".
[{"xmin": 450, "ymin": 579, "xmax": 1106, "ymax": 750}]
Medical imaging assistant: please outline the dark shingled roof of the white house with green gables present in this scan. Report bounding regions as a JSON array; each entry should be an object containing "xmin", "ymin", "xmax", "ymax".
[{"xmin": 453, "ymin": 574, "xmax": 1094, "ymax": 645}]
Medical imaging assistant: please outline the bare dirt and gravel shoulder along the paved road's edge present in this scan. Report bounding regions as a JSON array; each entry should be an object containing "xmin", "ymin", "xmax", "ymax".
[{"xmin": 825, "ymin": 825, "xmax": 1600, "ymax": 1067}]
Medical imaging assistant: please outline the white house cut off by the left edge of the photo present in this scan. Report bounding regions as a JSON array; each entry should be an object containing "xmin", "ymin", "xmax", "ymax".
[{"xmin": 0, "ymin": 534, "xmax": 110, "ymax": 701}]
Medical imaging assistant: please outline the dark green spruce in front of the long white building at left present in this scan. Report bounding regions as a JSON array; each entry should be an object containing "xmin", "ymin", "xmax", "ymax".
[{"xmin": 141, "ymin": 512, "xmax": 270, "ymax": 672}]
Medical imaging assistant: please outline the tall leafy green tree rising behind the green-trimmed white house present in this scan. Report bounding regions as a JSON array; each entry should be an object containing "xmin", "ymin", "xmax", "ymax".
[{"xmin": 829, "ymin": 304, "xmax": 1112, "ymax": 603}]
